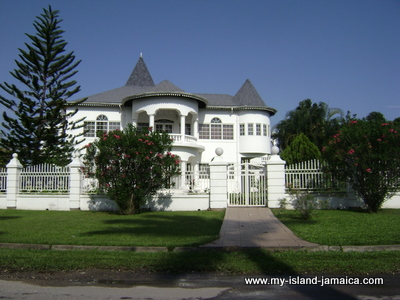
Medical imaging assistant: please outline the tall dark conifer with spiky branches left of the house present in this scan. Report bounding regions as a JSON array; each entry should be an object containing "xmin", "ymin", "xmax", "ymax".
[{"xmin": 0, "ymin": 6, "xmax": 84, "ymax": 165}]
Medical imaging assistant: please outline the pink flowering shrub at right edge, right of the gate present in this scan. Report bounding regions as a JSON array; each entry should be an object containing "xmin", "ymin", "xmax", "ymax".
[{"xmin": 322, "ymin": 119, "xmax": 400, "ymax": 212}]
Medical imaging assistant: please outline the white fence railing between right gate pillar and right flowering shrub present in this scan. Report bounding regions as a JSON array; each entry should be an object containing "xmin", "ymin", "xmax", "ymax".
[{"xmin": 285, "ymin": 159, "xmax": 346, "ymax": 191}]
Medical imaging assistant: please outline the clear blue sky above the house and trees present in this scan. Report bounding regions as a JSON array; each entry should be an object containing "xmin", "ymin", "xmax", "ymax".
[{"xmin": 0, "ymin": 0, "xmax": 400, "ymax": 124}]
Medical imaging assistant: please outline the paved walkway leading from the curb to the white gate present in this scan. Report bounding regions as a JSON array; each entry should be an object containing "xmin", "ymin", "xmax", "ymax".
[{"xmin": 202, "ymin": 207, "xmax": 318, "ymax": 248}]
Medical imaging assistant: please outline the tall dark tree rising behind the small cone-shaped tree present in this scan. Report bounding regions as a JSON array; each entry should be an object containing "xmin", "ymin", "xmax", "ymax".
[{"xmin": 273, "ymin": 99, "xmax": 344, "ymax": 151}]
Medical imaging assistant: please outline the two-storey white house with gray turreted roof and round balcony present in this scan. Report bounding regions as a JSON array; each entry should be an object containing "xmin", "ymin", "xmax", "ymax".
[{"xmin": 70, "ymin": 56, "xmax": 276, "ymax": 192}]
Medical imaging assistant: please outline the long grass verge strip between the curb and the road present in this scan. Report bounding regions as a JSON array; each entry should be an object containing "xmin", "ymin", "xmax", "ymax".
[{"xmin": 0, "ymin": 249, "xmax": 400, "ymax": 275}]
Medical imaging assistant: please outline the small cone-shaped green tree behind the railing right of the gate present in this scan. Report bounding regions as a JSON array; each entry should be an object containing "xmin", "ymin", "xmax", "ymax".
[{"xmin": 281, "ymin": 133, "xmax": 321, "ymax": 165}]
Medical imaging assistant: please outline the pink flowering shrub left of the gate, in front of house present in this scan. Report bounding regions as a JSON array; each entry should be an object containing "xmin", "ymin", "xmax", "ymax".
[{"xmin": 84, "ymin": 125, "xmax": 180, "ymax": 214}]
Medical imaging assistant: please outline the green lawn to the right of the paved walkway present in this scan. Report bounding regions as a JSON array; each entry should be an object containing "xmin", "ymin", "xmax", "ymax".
[{"xmin": 272, "ymin": 209, "xmax": 400, "ymax": 246}]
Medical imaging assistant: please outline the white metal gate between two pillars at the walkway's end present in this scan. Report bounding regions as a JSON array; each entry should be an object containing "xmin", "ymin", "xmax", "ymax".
[{"xmin": 227, "ymin": 162, "xmax": 267, "ymax": 206}]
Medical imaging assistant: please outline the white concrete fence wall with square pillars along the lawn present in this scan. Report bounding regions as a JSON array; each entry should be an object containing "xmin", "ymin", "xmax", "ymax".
[{"xmin": 0, "ymin": 147, "xmax": 400, "ymax": 211}]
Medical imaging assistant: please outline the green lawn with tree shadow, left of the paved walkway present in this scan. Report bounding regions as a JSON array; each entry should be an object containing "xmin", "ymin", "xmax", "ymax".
[{"xmin": 0, "ymin": 210, "xmax": 224, "ymax": 247}]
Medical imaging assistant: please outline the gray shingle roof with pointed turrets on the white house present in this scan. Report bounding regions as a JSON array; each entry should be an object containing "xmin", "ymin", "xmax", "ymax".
[{"xmin": 73, "ymin": 56, "xmax": 276, "ymax": 114}]
